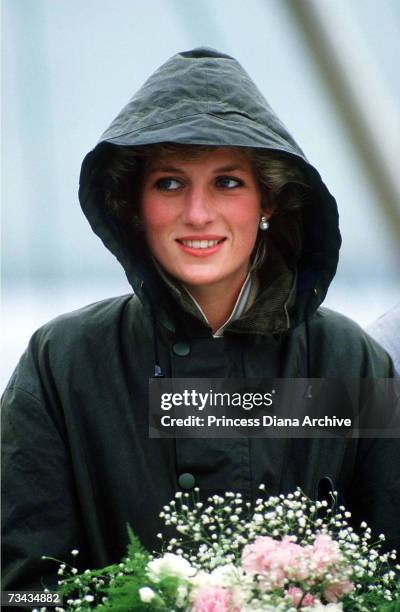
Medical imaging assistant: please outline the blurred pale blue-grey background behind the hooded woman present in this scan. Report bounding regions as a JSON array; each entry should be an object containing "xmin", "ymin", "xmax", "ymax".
[{"xmin": 0, "ymin": 0, "xmax": 400, "ymax": 388}]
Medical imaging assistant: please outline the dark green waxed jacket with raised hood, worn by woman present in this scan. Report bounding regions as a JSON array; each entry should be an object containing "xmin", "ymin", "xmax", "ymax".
[{"xmin": 2, "ymin": 48, "xmax": 400, "ymax": 589}]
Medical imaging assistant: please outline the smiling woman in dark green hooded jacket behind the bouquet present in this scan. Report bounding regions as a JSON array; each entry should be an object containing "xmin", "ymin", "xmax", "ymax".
[{"xmin": 3, "ymin": 49, "xmax": 400, "ymax": 588}]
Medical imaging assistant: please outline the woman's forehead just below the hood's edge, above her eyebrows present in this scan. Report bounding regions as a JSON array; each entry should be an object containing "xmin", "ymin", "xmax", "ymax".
[{"xmin": 147, "ymin": 146, "xmax": 253, "ymax": 172}]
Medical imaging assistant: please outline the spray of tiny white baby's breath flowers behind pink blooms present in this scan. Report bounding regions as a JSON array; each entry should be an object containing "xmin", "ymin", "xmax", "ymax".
[{"xmin": 155, "ymin": 485, "xmax": 397, "ymax": 610}]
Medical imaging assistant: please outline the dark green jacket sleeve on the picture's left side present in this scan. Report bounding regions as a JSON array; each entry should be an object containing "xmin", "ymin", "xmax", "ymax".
[{"xmin": 2, "ymin": 341, "xmax": 90, "ymax": 590}]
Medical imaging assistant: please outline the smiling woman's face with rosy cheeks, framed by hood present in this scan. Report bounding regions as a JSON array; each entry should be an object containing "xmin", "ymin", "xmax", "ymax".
[{"xmin": 142, "ymin": 147, "xmax": 268, "ymax": 288}]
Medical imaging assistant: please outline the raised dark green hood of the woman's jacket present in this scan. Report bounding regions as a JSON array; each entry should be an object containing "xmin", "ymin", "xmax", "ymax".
[{"xmin": 79, "ymin": 48, "xmax": 341, "ymax": 331}]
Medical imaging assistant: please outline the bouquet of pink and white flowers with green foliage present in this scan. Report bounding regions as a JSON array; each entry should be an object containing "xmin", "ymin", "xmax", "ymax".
[{"xmin": 42, "ymin": 485, "xmax": 400, "ymax": 612}]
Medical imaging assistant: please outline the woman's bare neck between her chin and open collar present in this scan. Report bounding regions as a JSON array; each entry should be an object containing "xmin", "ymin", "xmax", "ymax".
[{"xmin": 186, "ymin": 275, "xmax": 247, "ymax": 332}]
